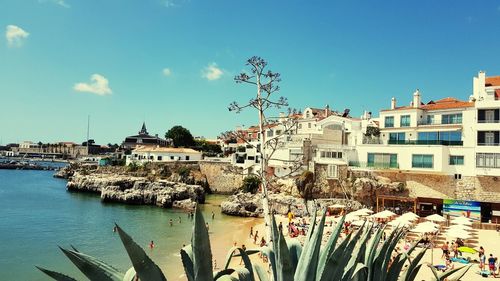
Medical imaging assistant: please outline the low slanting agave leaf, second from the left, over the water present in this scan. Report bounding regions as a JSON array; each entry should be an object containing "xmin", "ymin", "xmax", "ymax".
[{"xmin": 59, "ymin": 247, "xmax": 124, "ymax": 281}]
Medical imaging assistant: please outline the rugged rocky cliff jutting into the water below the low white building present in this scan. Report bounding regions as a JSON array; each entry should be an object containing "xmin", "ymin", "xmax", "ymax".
[{"xmin": 66, "ymin": 172, "xmax": 205, "ymax": 208}]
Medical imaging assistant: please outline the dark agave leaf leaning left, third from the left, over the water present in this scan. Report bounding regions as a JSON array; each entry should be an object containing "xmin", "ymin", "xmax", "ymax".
[{"xmin": 115, "ymin": 224, "xmax": 167, "ymax": 281}]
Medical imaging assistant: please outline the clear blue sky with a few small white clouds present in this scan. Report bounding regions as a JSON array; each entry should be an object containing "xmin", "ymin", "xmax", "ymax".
[{"xmin": 0, "ymin": 0, "xmax": 500, "ymax": 144}]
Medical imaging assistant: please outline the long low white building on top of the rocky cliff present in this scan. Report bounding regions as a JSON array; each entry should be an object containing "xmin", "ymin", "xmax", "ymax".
[{"xmin": 126, "ymin": 146, "xmax": 202, "ymax": 165}]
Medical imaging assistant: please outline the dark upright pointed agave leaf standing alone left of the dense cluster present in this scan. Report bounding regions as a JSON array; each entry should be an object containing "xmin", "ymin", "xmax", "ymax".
[{"xmin": 191, "ymin": 203, "xmax": 213, "ymax": 281}]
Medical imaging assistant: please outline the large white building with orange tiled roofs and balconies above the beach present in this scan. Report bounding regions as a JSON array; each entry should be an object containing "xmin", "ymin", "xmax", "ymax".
[{"xmin": 356, "ymin": 72, "xmax": 500, "ymax": 176}]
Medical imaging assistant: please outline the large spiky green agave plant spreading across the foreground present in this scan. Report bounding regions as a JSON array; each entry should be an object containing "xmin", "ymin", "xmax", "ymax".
[{"xmin": 37, "ymin": 203, "xmax": 470, "ymax": 281}]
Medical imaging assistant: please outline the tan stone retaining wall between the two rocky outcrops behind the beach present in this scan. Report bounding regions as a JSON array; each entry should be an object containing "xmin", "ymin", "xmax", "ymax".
[{"xmin": 199, "ymin": 162, "xmax": 244, "ymax": 194}]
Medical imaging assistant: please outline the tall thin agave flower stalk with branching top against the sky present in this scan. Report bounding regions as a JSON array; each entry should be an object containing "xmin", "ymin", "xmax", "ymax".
[{"xmin": 229, "ymin": 56, "xmax": 288, "ymax": 241}]
